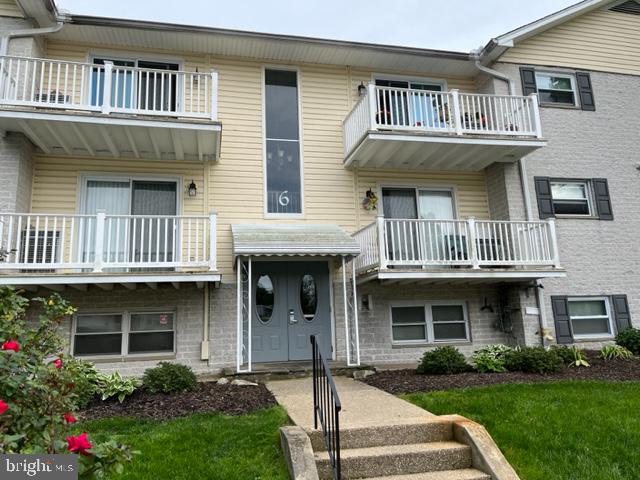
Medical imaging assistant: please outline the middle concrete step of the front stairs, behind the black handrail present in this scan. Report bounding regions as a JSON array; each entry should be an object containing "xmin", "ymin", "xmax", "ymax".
[{"xmin": 315, "ymin": 441, "xmax": 471, "ymax": 480}]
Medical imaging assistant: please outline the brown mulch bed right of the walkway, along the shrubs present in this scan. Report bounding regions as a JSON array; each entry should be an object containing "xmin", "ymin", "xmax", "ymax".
[{"xmin": 362, "ymin": 352, "xmax": 640, "ymax": 394}]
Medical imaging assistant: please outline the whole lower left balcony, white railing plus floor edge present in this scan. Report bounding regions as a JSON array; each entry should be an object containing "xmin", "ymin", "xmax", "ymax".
[{"xmin": 0, "ymin": 213, "xmax": 220, "ymax": 286}]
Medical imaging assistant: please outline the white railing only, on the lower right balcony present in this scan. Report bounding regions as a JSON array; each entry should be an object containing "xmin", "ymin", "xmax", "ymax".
[{"xmin": 354, "ymin": 217, "xmax": 560, "ymax": 271}]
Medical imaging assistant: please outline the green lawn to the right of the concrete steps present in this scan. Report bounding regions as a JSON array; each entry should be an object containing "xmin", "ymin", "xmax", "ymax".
[{"xmin": 403, "ymin": 382, "xmax": 640, "ymax": 480}]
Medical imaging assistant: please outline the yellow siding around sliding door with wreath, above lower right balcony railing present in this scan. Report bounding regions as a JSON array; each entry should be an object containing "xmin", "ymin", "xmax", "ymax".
[{"xmin": 357, "ymin": 170, "xmax": 490, "ymax": 228}]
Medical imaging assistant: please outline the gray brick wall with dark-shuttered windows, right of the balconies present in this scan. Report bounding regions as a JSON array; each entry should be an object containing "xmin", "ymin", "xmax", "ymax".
[{"xmin": 484, "ymin": 64, "xmax": 640, "ymax": 346}]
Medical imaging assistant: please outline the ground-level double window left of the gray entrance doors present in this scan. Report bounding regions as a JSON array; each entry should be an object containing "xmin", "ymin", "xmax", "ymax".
[{"xmin": 73, "ymin": 311, "xmax": 175, "ymax": 357}]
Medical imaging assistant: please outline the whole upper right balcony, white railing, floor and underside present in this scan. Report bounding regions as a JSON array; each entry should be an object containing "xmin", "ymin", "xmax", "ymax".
[{"xmin": 343, "ymin": 85, "xmax": 546, "ymax": 171}]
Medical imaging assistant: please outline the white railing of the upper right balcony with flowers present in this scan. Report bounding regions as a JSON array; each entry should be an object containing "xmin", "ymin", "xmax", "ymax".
[{"xmin": 343, "ymin": 84, "xmax": 542, "ymax": 154}]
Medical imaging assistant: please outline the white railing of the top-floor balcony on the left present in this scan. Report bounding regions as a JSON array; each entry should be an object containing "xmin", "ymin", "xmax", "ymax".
[{"xmin": 0, "ymin": 56, "xmax": 218, "ymax": 120}]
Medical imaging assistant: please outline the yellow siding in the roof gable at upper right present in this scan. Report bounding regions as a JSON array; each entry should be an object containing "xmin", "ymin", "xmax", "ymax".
[{"xmin": 499, "ymin": 10, "xmax": 640, "ymax": 75}]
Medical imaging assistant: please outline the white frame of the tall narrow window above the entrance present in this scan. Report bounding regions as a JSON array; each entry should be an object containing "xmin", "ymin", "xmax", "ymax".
[{"xmin": 261, "ymin": 64, "xmax": 305, "ymax": 219}]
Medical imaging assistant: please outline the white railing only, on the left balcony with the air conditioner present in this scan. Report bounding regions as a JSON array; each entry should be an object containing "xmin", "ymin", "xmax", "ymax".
[{"xmin": 0, "ymin": 213, "xmax": 216, "ymax": 272}]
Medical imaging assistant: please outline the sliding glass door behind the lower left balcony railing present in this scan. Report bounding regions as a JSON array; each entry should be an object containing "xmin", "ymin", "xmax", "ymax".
[{"xmin": 79, "ymin": 177, "xmax": 178, "ymax": 263}]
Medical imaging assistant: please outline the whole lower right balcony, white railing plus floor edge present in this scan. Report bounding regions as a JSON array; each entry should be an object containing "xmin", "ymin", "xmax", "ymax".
[{"xmin": 353, "ymin": 217, "xmax": 564, "ymax": 283}]
